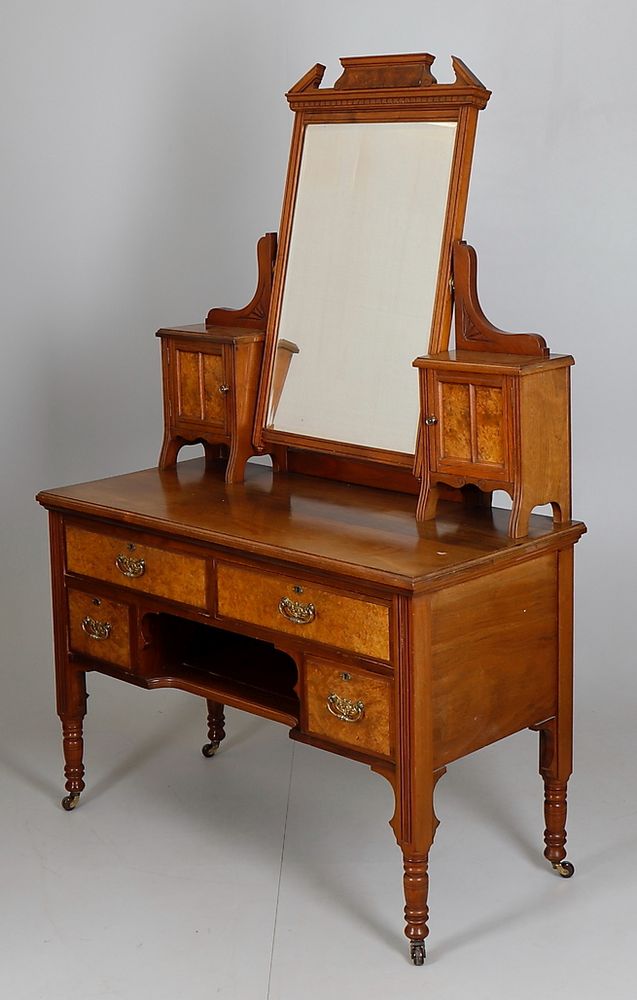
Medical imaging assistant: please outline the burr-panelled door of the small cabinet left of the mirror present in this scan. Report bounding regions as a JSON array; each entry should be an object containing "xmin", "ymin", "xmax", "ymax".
[{"xmin": 171, "ymin": 344, "xmax": 229, "ymax": 433}]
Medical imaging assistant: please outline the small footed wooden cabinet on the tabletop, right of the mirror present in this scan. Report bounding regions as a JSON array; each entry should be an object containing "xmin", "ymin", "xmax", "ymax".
[{"xmin": 414, "ymin": 350, "xmax": 573, "ymax": 538}]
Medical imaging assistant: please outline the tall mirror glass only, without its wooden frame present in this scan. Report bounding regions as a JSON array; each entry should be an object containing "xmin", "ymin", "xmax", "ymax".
[{"xmin": 268, "ymin": 122, "xmax": 456, "ymax": 453}]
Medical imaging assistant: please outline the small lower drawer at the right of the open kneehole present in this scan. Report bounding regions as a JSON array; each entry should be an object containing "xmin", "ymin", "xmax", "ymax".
[{"xmin": 305, "ymin": 658, "xmax": 393, "ymax": 757}]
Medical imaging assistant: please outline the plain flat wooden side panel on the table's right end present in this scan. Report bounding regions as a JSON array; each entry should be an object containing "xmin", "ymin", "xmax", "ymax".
[{"xmin": 432, "ymin": 553, "xmax": 557, "ymax": 767}]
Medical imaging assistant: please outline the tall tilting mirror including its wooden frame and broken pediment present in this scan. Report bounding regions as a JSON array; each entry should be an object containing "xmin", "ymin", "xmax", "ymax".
[{"xmin": 254, "ymin": 54, "xmax": 489, "ymax": 477}]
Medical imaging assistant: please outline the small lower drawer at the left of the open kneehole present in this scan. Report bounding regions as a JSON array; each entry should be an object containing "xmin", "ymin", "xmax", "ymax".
[{"xmin": 69, "ymin": 590, "xmax": 131, "ymax": 669}]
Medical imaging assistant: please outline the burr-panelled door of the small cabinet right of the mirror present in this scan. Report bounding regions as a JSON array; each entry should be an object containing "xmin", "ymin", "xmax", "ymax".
[{"xmin": 426, "ymin": 371, "xmax": 511, "ymax": 482}]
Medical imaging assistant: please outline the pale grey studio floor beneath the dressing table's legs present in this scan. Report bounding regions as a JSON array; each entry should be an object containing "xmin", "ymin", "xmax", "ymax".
[{"xmin": 0, "ymin": 677, "xmax": 637, "ymax": 1000}]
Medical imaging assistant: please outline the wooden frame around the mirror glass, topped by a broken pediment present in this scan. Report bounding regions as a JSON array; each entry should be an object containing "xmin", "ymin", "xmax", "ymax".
[{"xmin": 254, "ymin": 53, "xmax": 491, "ymax": 492}]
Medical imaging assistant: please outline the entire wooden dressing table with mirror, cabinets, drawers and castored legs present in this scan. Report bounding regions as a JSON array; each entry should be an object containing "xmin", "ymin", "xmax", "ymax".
[{"xmin": 33, "ymin": 55, "xmax": 585, "ymax": 965}]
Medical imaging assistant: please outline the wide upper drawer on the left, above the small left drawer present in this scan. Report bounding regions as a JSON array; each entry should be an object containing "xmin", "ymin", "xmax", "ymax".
[{"xmin": 66, "ymin": 525, "xmax": 207, "ymax": 608}]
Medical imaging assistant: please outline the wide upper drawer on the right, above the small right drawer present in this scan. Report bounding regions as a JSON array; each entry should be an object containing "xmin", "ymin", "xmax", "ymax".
[{"xmin": 217, "ymin": 563, "xmax": 389, "ymax": 660}]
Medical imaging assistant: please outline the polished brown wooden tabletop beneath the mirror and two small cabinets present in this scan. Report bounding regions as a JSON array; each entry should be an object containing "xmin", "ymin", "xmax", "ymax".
[{"xmin": 37, "ymin": 459, "xmax": 586, "ymax": 590}]
